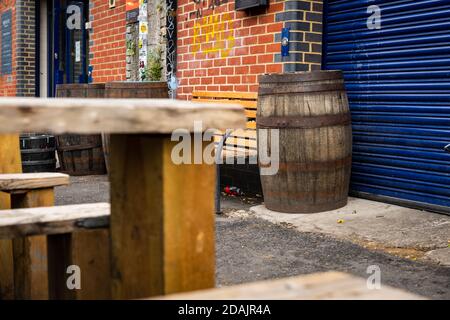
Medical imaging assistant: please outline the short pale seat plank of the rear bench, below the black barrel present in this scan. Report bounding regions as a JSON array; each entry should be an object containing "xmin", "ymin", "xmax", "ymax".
[{"xmin": 0, "ymin": 173, "xmax": 70, "ymax": 192}]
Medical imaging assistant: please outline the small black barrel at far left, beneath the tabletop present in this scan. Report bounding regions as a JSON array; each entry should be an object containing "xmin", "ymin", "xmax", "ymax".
[{"xmin": 20, "ymin": 134, "xmax": 56, "ymax": 173}]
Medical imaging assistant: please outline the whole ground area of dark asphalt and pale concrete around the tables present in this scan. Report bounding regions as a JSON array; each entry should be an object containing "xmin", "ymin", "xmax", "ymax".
[{"xmin": 56, "ymin": 176, "xmax": 450, "ymax": 299}]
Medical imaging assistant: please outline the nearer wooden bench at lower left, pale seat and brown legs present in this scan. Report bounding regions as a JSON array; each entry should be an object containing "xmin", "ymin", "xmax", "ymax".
[{"xmin": 0, "ymin": 203, "xmax": 111, "ymax": 300}]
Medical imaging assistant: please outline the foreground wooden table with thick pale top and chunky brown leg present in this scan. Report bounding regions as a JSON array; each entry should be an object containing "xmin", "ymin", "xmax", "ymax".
[{"xmin": 0, "ymin": 98, "xmax": 246, "ymax": 299}]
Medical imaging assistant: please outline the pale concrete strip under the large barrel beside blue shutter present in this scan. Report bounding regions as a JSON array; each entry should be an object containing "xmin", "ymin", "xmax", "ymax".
[{"xmin": 251, "ymin": 198, "xmax": 450, "ymax": 267}]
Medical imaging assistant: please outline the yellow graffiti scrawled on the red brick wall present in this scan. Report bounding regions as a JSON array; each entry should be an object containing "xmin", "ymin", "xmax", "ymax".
[{"xmin": 192, "ymin": 13, "xmax": 235, "ymax": 58}]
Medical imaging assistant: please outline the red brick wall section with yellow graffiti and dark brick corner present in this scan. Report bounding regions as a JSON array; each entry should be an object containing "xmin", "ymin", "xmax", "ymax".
[{"xmin": 177, "ymin": 0, "xmax": 323, "ymax": 99}]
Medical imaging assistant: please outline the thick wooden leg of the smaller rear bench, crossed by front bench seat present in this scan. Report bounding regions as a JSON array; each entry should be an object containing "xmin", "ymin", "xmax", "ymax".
[{"xmin": 11, "ymin": 188, "xmax": 55, "ymax": 300}]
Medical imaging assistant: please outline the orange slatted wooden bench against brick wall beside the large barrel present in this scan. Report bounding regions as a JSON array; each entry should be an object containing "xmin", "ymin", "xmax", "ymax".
[{"xmin": 192, "ymin": 91, "xmax": 258, "ymax": 158}]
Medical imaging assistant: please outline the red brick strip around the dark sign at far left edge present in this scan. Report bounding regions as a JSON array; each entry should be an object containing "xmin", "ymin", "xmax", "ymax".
[{"xmin": 0, "ymin": 0, "xmax": 16, "ymax": 97}]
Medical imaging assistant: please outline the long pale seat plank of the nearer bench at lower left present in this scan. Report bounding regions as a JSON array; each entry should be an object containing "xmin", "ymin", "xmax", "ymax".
[{"xmin": 0, "ymin": 203, "xmax": 110, "ymax": 239}]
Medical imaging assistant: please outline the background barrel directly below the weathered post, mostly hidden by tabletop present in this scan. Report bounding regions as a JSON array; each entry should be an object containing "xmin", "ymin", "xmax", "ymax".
[{"xmin": 102, "ymin": 81, "xmax": 169, "ymax": 170}]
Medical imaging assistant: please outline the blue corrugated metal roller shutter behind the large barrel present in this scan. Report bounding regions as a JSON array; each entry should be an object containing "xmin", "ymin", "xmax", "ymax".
[{"xmin": 324, "ymin": 0, "xmax": 450, "ymax": 212}]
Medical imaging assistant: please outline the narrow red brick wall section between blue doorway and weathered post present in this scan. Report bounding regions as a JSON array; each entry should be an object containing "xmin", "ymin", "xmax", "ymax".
[{"xmin": 89, "ymin": 0, "xmax": 126, "ymax": 82}]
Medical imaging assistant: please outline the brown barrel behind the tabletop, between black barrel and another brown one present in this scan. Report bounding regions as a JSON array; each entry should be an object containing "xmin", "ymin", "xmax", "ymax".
[{"xmin": 56, "ymin": 83, "xmax": 106, "ymax": 176}]
